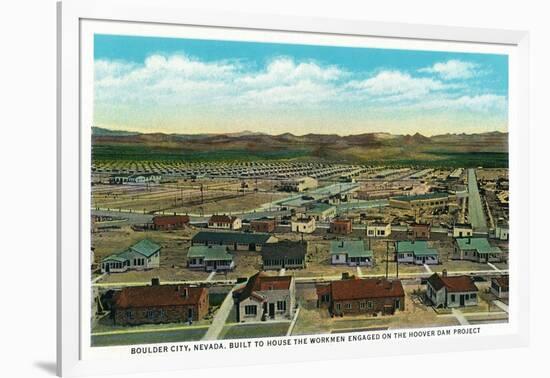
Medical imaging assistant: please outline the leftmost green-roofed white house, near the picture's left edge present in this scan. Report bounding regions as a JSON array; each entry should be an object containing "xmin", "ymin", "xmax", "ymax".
[{"xmin": 101, "ymin": 239, "xmax": 162, "ymax": 273}]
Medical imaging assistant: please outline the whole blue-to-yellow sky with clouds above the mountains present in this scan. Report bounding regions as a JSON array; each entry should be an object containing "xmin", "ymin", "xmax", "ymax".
[{"xmin": 94, "ymin": 35, "xmax": 508, "ymax": 135}]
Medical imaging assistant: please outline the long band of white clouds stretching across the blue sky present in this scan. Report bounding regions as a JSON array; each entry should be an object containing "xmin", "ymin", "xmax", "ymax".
[{"xmin": 95, "ymin": 54, "xmax": 506, "ymax": 115}]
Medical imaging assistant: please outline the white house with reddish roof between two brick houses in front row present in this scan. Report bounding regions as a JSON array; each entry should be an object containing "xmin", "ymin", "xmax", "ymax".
[{"xmin": 233, "ymin": 273, "xmax": 296, "ymax": 323}]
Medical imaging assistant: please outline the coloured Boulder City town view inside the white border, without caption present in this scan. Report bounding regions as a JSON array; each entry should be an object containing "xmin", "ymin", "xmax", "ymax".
[{"xmin": 88, "ymin": 33, "xmax": 509, "ymax": 348}]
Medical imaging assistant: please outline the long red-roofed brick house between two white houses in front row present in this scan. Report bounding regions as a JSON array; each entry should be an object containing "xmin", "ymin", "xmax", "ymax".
[{"xmin": 316, "ymin": 278, "xmax": 405, "ymax": 316}]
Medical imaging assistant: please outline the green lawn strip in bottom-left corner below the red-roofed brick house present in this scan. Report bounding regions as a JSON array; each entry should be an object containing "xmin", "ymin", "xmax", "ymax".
[{"xmin": 92, "ymin": 327, "xmax": 208, "ymax": 346}]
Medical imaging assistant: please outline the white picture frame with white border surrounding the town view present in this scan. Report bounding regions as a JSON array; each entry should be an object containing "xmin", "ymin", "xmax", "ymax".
[{"xmin": 57, "ymin": 0, "xmax": 530, "ymax": 376}]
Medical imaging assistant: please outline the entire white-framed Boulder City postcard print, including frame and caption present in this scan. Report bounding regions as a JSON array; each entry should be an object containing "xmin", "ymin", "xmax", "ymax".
[{"xmin": 58, "ymin": 0, "xmax": 529, "ymax": 376}]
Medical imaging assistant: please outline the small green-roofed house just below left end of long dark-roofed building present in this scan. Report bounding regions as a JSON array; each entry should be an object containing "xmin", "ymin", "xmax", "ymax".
[{"xmin": 187, "ymin": 245, "xmax": 235, "ymax": 272}]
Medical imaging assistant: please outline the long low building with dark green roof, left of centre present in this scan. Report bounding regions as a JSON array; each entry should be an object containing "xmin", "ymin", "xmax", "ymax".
[{"xmin": 191, "ymin": 231, "xmax": 277, "ymax": 251}]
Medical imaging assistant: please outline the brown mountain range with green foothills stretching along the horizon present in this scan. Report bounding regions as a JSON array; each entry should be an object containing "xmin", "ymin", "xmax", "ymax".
[{"xmin": 92, "ymin": 127, "xmax": 508, "ymax": 166}]
